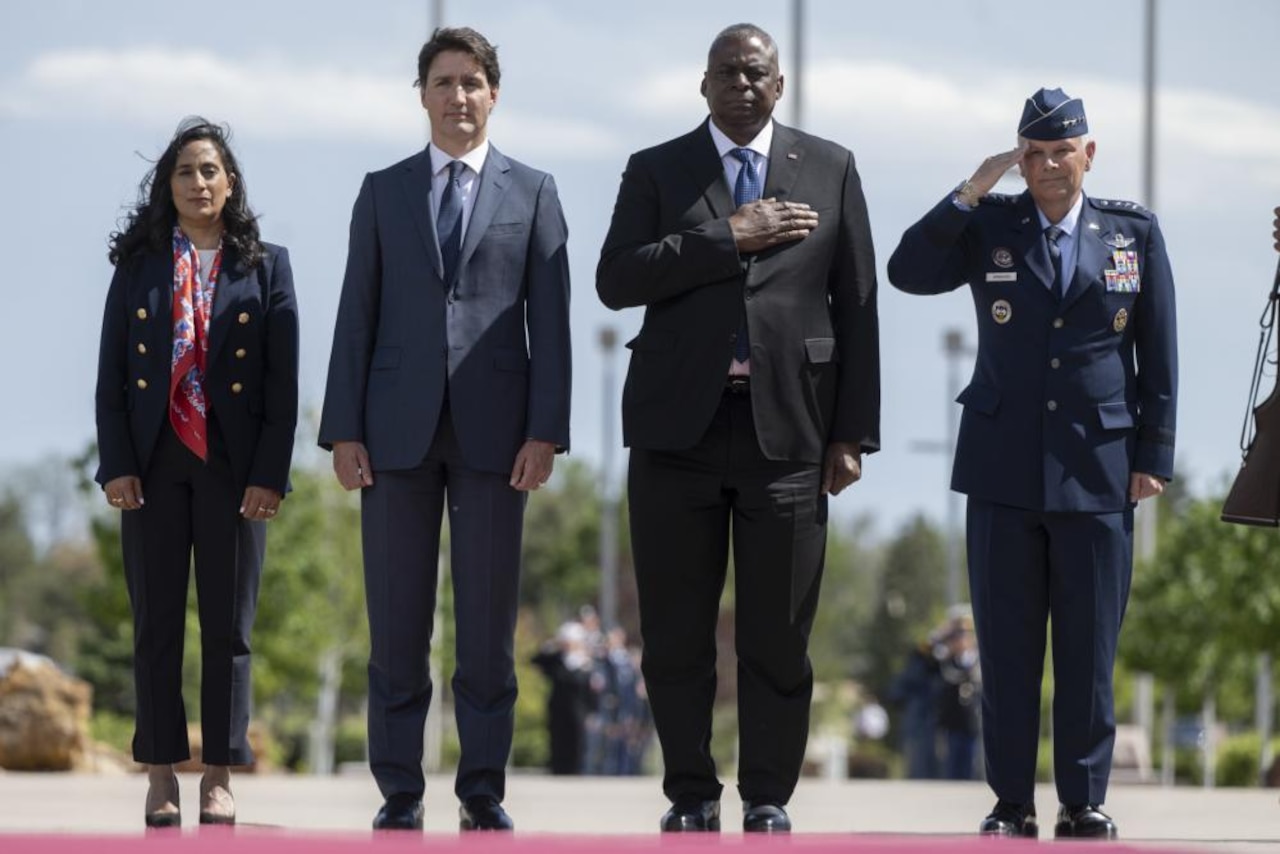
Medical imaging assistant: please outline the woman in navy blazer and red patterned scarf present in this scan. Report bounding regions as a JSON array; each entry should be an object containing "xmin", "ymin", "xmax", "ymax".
[{"xmin": 96, "ymin": 118, "xmax": 298, "ymax": 827}]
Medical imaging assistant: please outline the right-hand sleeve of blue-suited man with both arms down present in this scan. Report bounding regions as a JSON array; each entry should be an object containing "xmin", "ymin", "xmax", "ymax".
[{"xmin": 525, "ymin": 175, "xmax": 572, "ymax": 451}]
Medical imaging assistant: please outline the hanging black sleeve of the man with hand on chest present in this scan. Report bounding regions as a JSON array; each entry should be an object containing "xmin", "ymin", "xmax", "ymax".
[{"xmin": 818, "ymin": 152, "xmax": 881, "ymax": 453}]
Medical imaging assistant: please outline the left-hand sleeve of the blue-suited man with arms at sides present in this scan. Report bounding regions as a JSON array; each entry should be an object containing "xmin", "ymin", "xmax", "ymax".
[{"xmin": 319, "ymin": 175, "xmax": 381, "ymax": 451}]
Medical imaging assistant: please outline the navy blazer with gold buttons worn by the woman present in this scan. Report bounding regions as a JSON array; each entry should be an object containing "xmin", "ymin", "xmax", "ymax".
[{"xmin": 96, "ymin": 243, "xmax": 298, "ymax": 494}]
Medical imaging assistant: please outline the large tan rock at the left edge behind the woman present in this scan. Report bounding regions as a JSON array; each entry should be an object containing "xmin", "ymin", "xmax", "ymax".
[{"xmin": 0, "ymin": 649, "xmax": 93, "ymax": 771}]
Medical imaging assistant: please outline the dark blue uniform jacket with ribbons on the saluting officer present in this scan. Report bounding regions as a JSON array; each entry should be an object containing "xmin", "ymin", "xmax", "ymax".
[{"xmin": 888, "ymin": 192, "xmax": 1178, "ymax": 512}]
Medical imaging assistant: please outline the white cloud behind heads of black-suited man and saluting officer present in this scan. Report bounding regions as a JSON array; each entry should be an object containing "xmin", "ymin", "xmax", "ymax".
[{"xmin": 631, "ymin": 59, "xmax": 1280, "ymax": 189}]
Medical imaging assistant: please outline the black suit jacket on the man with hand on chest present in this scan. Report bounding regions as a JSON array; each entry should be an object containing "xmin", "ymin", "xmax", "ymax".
[{"xmin": 595, "ymin": 122, "xmax": 879, "ymax": 463}]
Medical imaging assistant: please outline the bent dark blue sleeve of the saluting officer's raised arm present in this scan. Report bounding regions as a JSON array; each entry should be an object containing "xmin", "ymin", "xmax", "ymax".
[{"xmin": 888, "ymin": 193, "xmax": 972, "ymax": 294}]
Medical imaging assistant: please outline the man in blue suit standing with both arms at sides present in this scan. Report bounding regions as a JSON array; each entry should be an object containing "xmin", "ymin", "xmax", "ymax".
[{"xmin": 320, "ymin": 28, "xmax": 571, "ymax": 830}]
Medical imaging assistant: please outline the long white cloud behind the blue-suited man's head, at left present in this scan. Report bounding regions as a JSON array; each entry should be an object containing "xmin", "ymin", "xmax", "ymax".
[{"xmin": 0, "ymin": 47, "xmax": 622, "ymax": 154}]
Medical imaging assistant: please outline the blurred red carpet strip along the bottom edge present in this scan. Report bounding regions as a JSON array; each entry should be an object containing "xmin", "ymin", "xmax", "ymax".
[{"xmin": 0, "ymin": 827, "xmax": 1198, "ymax": 854}]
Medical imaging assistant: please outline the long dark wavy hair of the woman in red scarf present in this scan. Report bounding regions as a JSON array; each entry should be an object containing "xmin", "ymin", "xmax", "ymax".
[{"xmin": 106, "ymin": 115, "xmax": 262, "ymax": 268}]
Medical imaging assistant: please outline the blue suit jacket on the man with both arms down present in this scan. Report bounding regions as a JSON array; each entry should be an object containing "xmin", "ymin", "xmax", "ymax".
[{"xmin": 320, "ymin": 146, "xmax": 572, "ymax": 474}]
